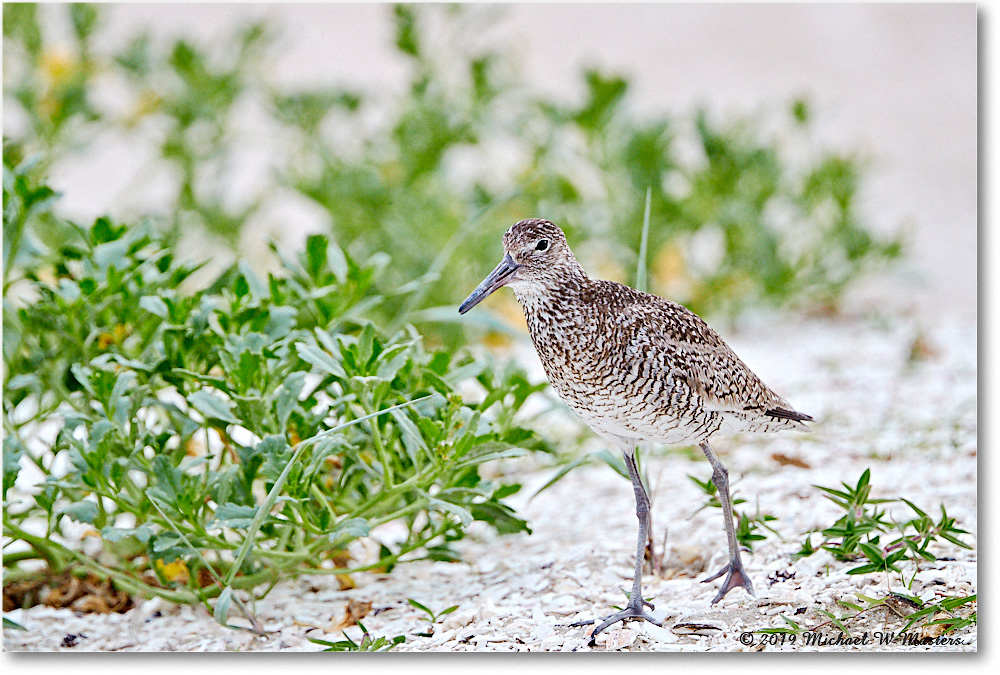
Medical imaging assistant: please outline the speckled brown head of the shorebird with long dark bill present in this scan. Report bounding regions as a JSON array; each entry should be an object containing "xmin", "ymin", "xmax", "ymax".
[{"xmin": 458, "ymin": 218, "xmax": 583, "ymax": 314}]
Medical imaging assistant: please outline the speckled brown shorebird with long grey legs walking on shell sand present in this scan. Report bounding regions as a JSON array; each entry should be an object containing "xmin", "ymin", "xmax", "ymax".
[{"xmin": 458, "ymin": 218, "xmax": 812, "ymax": 644}]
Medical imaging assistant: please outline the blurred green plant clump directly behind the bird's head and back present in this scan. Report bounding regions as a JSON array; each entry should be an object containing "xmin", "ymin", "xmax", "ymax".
[{"xmin": 280, "ymin": 6, "xmax": 900, "ymax": 320}]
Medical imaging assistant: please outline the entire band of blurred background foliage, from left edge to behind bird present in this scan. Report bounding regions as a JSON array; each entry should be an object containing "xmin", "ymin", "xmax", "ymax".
[{"xmin": 4, "ymin": 5, "xmax": 901, "ymax": 339}]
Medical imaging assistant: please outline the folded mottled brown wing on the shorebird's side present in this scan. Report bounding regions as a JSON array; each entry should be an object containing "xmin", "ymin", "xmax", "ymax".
[{"xmin": 620, "ymin": 298, "xmax": 791, "ymax": 416}]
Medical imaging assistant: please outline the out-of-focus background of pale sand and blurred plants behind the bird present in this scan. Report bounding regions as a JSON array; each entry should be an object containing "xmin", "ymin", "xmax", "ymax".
[{"xmin": 4, "ymin": 4, "xmax": 977, "ymax": 342}]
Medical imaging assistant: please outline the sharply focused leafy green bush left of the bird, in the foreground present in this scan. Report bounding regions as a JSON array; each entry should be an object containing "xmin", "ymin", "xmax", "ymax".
[{"xmin": 3, "ymin": 163, "xmax": 547, "ymax": 623}]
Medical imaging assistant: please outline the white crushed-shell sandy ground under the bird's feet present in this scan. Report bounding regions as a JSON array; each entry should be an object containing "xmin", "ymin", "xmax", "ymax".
[{"xmin": 4, "ymin": 317, "xmax": 978, "ymax": 651}]
